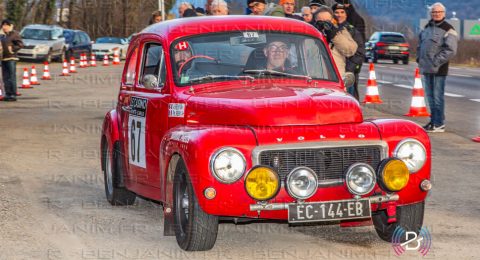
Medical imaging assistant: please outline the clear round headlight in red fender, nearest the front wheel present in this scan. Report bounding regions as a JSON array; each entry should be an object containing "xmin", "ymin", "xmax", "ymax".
[{"xmin": 210, "ymin": 147, "xmax": 247, "ymax": 183}]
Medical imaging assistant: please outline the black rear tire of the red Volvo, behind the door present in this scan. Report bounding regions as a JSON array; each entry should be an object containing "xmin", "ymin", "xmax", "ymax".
[{"xmin": 102, "ymin": 141, "xmax": 137, "ymax": 206}]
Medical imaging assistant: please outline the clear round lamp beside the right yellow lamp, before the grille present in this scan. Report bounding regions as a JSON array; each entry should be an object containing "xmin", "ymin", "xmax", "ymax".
[{"xmin": 346, "ymin": 163, "xmax": 375, "ymax": 195}]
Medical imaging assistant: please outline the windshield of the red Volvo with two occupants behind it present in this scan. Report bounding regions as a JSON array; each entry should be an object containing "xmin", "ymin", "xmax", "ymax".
[{"xmin": 171, "ymin": 31, "xmax": 338, "ymax": 86}]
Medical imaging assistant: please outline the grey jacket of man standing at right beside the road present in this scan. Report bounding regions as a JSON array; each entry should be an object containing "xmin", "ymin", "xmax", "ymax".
[{"xmin": 417, "ymin": 20, "xmax": 458, "ymax": 76}]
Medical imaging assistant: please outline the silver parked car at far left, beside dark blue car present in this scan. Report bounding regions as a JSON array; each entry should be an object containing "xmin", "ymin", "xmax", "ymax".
[{"xmin": 17, "ymin": 24, "xmax": 67, "ymax": 62}]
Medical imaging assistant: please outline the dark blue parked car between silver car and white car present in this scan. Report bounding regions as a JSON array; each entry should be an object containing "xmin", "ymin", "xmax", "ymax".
[{"xmin": 63, "ymin": 29, "xmax": 92, "ymax": 59}]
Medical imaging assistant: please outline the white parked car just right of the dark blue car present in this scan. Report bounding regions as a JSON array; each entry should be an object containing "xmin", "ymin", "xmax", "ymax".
[{"xmin": 92, "ymin": 37, "xmax": 128, "ymax": 60}]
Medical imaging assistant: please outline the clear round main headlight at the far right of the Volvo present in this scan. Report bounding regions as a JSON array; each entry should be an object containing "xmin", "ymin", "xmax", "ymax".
[{"xmin": 393, "ymin": 138, "xmax": 427, "ymax": 173}]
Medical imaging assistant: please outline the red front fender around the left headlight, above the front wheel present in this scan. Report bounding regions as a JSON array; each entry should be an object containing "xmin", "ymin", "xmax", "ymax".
[{"xmin": 160, "ymin": 126, "xmax": 257, "ymax": 214}]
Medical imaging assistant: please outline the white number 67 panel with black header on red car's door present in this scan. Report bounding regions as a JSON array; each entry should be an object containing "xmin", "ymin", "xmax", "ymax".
[{"xmin": 128, "ymin": 97, "xmax": 147, "ymax": 168}]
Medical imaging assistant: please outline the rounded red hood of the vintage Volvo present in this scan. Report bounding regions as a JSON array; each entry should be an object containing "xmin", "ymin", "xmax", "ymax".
[{"xmin": 185, "ymin": 84, "xmax": 363, "ymax": 126}]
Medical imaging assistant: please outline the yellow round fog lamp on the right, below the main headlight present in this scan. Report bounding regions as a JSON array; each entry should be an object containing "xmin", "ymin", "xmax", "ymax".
[{"xmin": 378, "ymin": 158, "xmax": 410, "ymax": 191}]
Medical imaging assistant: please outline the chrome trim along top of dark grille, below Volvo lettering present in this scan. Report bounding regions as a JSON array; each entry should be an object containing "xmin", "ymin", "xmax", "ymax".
[{"xmin": 252, "ymin": 140, "xmax": 388, "ymax": 166}]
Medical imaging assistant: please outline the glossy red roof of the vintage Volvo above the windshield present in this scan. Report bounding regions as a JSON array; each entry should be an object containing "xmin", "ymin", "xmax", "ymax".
[{"xmin": 136, "ymin": 15, "xmax": 321, "ymax": 42}]
